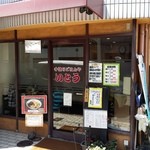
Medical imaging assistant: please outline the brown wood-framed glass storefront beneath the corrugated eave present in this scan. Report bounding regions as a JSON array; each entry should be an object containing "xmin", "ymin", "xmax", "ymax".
[{"xmin": 0, "ymin": 1, "xmax": 150, "ymax": 149}]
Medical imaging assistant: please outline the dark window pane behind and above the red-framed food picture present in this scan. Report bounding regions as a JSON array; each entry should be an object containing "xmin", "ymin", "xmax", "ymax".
[{"xmin": 19, "ymin": 41, "xmax": 48, "ymax": 116}]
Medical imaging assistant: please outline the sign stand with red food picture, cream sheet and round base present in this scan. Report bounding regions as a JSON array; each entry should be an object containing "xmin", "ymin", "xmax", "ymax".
[{"xmin": 21, "ymin": 95, "xmax": 47, "ymax": 141}]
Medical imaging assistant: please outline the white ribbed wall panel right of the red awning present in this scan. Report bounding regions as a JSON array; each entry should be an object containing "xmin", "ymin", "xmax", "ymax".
[{"xmin": 103, "ymin": 0, "xmax": 150, "ymax": 19}]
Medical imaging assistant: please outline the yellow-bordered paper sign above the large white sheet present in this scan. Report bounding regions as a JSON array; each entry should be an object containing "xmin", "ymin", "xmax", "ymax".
[{"xmin": 88, "ymin": 88, "xmax": 102, "ymax": 108}]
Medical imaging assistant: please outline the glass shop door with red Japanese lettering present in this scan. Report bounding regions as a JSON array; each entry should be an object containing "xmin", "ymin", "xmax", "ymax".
[{"xmin": 52, "ymin": 40, "xmax": 85, "ymax": 139}]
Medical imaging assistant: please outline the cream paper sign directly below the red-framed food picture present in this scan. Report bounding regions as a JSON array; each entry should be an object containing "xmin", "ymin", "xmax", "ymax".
[{"xmin": 25, "ymin": 114, "xmax": 43, "ymax": 127}]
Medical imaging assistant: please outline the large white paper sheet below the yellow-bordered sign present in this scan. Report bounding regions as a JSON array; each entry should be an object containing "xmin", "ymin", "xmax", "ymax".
[{"xmin": 84, "ymin": 109, "xmax": 107, "ymax": 129}]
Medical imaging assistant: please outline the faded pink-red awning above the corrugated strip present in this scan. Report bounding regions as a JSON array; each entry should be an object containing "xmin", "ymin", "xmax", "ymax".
[{"xmin": 0, "ymin": 0, "xmax": 103, "ymax": 18}]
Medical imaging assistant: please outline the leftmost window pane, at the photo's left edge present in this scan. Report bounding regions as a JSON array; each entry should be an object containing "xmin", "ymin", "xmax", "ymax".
[{"xmin": 0, "ymin": 43, "xmax": 16, "ymax": 116}]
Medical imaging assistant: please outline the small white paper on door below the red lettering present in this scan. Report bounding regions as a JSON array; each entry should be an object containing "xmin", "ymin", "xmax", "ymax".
[{"xmin": 63, "ymin": 93, "xmax": 72, "ymax": 106}]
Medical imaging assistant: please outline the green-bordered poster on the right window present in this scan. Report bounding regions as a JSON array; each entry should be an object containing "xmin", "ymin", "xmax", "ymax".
[{"xmin": 103, "ymin": 63, "xmax": 120, "ymax": 86}]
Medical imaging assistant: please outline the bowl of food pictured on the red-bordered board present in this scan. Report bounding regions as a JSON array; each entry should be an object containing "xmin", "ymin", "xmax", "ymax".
[{"xmin": 26, "ymin": 99, "xmax": 42, "ymax": 109}]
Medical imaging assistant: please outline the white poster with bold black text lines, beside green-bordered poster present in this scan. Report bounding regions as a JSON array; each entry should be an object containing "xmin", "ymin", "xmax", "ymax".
[{"xmin": 89, "ymin": 63, "xmax": 102, "ymax": 83}]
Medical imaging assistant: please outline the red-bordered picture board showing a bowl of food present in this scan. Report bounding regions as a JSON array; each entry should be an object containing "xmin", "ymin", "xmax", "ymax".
[{"xmin": 21, "ymin": 95, "xmax": 47, "ymax": 114}]
